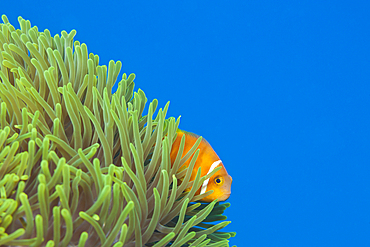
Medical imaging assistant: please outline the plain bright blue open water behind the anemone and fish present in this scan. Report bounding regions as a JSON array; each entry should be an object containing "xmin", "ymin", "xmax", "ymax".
[{"xmin": 1, "ymin": 0, "xmax": 370, "ymax": 247}]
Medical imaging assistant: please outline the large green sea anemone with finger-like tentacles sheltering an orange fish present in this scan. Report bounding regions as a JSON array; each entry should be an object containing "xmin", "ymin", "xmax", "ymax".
[{"xmin": 0, "ymin": 15, "xmax": 235, "ymax": 247}]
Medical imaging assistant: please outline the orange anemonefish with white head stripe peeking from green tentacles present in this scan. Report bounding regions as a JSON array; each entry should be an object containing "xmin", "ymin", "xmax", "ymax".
[{"xmin": 171, "ymin": 130, "xmax": 233, "ymax": 202}]
